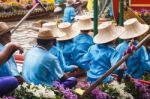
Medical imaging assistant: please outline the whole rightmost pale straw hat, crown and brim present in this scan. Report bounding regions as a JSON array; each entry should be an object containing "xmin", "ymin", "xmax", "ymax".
[{"xmin": 120, "ymin": 18, "xmax": 149, "ymax": 39}]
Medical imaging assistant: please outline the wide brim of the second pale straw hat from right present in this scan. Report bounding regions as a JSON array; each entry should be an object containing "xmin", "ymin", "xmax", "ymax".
[{"xmin": 93, "ymin": 26, "xmax": 124, "ymax": 44}]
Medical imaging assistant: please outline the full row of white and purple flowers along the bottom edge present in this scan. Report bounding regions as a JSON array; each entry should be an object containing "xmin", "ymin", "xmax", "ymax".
[{"xmin": 2, "ymin": 78, "xmax": 150, "ymax": 99}]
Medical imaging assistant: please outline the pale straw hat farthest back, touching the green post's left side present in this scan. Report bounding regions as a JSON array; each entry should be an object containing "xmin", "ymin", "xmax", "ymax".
[{"xmin": 73, "ymin": 15, "xmax": 93, "ymax": 30}]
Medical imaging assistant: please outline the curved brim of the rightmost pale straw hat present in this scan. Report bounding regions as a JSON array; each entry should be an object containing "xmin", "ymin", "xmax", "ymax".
[{"xmin": 119, "ymin": 24, "xmax": 150, "ymax": 39}]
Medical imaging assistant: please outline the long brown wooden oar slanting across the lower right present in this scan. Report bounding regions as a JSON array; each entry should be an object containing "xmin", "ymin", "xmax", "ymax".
[{"xmin": 81, "ymin": 34, "xmax": 150, "ymax": 99}]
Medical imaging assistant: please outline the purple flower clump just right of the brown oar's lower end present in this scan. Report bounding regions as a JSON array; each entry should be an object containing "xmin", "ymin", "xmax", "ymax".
[{"xmin": 91, "ymin": 87, "xmax": 110, "ymax": 99}]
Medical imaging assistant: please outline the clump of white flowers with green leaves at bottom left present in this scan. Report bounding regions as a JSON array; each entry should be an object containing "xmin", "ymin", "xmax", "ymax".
[{"xmin": 13, "ymin": 83, "xmax": 55, "ymax": 99}]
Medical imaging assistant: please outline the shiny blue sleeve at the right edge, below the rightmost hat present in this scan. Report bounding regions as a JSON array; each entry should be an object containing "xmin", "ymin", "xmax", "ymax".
[{"xmin": 140, "ymin": 46, "xmax": 150, "ymax": 72}]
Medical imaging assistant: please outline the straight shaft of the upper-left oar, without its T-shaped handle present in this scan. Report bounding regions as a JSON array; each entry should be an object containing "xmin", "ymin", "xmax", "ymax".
[{"xmin": 12, "ymin": 3, "xmax": 39, "ymax": 33}]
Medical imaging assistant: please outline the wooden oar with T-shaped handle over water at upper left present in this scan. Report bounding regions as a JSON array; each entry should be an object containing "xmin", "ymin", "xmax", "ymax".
[{"xmin": 12, "ymin": 0, "xmax": 47, "ymax": 33}]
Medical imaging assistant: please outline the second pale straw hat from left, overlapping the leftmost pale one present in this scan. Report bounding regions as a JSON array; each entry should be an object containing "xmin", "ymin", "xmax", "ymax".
[{"xmin": 57, "ymin": 22, "xmax": 79, "ymax": 41}]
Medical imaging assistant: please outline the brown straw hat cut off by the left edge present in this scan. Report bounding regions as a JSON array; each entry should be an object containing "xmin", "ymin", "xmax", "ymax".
[{"xmin": 0, "ymin": 22, "xmax": 13, "ymax": 35}]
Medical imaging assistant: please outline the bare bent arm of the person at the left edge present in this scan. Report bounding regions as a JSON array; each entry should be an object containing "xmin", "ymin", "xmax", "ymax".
[{"xmin": 0, "ymin": 43, "xmax": 23, "ymax": 64}]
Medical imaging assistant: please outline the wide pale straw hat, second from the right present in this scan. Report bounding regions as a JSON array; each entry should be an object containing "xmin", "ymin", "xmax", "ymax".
[{"xmin": 94, "ymin": 21, "xmax": 124, "ymax": 44}]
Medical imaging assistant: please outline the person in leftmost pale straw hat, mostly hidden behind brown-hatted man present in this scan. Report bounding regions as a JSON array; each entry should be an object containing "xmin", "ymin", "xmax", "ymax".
[{"xmin": 42, "ymin": 22, "xmax": 77, "ymax": 72}]
